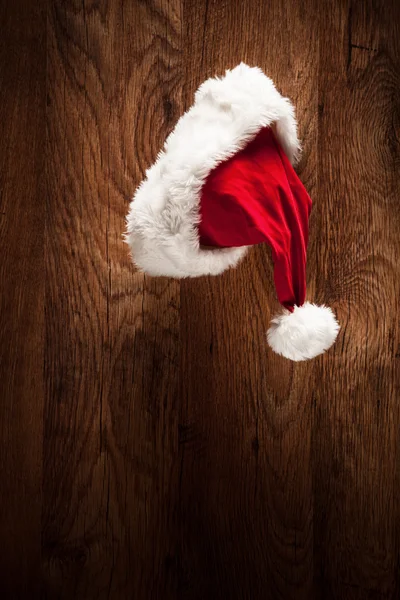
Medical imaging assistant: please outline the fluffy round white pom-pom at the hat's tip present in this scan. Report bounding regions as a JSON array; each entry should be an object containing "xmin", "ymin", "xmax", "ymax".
[{"xmin": 267, "ymin": 302, "xmax": 340, "ymax": 361}]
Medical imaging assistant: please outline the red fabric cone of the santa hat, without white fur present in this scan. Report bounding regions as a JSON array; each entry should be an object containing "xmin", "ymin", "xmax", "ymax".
[{"xmin": 199, "ymin": 127, "xmax": 311, "ymax": 312}]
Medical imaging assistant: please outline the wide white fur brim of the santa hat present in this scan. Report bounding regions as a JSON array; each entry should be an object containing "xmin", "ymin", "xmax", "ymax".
[{"xmin": 126, "ymin": 63, "xmax": 299, "ymax": 277}]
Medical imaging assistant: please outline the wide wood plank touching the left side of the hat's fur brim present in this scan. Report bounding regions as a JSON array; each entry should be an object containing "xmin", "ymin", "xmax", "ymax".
[{"xmin": 43, "ymin": 1, "xmax": 182, "ymax": 599}]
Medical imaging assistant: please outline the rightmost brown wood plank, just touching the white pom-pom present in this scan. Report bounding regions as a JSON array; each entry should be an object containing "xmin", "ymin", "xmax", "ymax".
[{"xmin": 313, "ymin": 2, "xmax": 400, "ymax": 598}]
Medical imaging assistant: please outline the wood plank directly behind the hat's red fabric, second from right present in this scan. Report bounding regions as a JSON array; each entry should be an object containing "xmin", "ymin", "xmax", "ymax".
[{"xmin": 180, "ymin": 0, "xmax": 318, "ymax": 599}]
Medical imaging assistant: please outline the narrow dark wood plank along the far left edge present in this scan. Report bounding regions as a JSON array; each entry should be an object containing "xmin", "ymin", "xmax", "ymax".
[{"xmin": 0, "ymin": 0, "xmax": 46, "ymax": 598}]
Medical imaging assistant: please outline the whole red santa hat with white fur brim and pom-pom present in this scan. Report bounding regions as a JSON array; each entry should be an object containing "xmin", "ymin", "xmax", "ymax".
[{"xmin": 126, "ymin": 64, "xmax": 339, "ymax": 361}]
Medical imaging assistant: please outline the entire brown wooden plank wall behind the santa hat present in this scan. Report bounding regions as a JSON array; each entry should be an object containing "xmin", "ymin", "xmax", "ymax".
[{"xmin": 0, "ymin": 0, "xmax": 400, "ymax": 600}]
